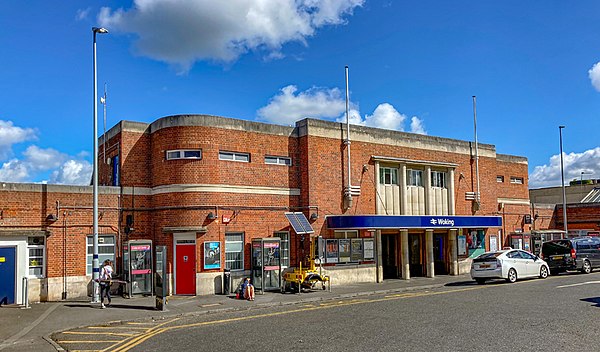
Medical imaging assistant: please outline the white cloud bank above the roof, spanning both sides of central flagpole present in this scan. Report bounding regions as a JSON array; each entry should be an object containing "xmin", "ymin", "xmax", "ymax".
[{"xmin": 257, "ymin": 85, "xmax": 427, "ymax": 134}]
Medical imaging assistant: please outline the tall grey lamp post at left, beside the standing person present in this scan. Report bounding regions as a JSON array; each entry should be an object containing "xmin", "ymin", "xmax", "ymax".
[{"xmin": 92, "ymin": 27, "xmax": 108, "ymax": 303}]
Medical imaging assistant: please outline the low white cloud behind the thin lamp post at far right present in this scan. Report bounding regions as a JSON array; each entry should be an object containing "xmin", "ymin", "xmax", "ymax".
[{"xmin": 529, "ymin": 147, "xmax": 600, "ymax": 188}]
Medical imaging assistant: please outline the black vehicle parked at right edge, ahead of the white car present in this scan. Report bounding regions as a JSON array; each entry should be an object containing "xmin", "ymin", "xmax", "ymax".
[{"xmin": 541, "ymin": 237, "xmax": 600, "ymax": 275}]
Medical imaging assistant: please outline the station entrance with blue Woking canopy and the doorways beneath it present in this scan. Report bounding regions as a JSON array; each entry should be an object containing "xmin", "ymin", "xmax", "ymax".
[{"xmin": 326, "ymin": 215, "xmax": 502, "ymax": 280}]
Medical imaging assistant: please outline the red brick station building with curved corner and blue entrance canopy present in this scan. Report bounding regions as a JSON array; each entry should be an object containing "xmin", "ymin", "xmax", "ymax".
[{"xmin": 0, "ymin": 115, "xmax": 530, "ymax": 301}]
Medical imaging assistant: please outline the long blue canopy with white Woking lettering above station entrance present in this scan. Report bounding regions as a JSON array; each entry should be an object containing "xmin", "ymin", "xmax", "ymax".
[{"xmin": 326, "ymin": 215, "xmax": 502, "ymax": 229}]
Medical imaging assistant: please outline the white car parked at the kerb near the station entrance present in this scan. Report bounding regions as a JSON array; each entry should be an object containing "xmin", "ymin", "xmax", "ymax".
[{"xmin": 471, "ymin": 249, "xmax": 550, "ymax": 284}]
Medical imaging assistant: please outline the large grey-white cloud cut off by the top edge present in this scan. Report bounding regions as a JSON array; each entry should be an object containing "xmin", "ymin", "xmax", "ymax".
[{"xmin": 98, "ymin": 0, "xmax": 364, "ymax": 72}]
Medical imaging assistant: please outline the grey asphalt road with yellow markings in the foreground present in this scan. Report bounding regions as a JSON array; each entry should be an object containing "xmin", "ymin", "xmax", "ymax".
[{"xmin": 51, "ymin": 273, "xmax": 600, "ymax": 352}]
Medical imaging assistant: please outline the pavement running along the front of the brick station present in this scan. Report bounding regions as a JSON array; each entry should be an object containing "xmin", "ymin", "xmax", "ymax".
[{"xmin": 0, "ymin": 275, "xmax": 473, "ymax": 351}]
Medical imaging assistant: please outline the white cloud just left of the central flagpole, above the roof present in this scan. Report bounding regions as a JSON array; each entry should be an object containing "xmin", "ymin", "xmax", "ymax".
[{"xmin": 257, "ymin": 85, "xmax": 346, "ymax": 125}]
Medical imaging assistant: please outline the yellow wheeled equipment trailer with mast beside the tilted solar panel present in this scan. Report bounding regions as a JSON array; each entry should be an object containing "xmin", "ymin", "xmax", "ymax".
[{"xmin": 281, "ymin": 236, "xmax": 331, "ymax": 293}]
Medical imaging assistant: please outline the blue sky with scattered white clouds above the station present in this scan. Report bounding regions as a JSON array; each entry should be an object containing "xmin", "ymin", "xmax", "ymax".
[{"xmin": 0, "ymin": 0, "xmax": 600, "ymax": 187}]
